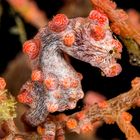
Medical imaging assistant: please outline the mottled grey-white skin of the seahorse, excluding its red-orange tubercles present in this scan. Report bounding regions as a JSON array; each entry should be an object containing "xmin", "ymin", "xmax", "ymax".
[{"xmin": 21, "ymin": 15, "xmax": 119, "ymax": 126}]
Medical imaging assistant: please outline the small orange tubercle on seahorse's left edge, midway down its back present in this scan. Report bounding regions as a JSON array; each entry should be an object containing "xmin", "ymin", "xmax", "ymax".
[{"xmin": 31, "ymin": 70, "xmax": 43, "ymax": 81}]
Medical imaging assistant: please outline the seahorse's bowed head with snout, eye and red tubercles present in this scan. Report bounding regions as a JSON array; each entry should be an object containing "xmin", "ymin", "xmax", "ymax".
[{"xmin": 48, "ymin": 10, "xmax": 122, "ymax": 77}]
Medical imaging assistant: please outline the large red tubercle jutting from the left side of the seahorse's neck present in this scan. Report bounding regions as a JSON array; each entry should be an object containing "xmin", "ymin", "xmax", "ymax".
[{"xmin": 23, "ymin": 39, "xmax": 40, "ymax": 59}]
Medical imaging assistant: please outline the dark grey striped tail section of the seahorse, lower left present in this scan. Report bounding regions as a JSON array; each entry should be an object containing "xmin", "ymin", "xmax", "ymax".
[{"xmin": 21, "ymin": 81, "xmax": 48, "ymax": 126}]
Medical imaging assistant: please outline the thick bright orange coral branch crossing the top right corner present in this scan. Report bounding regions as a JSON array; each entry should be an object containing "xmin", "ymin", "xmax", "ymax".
[{"xmin": 91, "ymin": 0, "xmax": 140, "ymax": 45}]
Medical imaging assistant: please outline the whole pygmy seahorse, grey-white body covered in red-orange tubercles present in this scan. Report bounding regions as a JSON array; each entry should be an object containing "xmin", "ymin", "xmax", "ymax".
[{"xmin": 18, "ymin": 10, "xmax": 122, "ymax": 126}]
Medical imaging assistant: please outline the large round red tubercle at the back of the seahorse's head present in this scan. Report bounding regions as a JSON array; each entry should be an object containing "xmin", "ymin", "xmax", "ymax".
[{"xmin": 48, "ymin": 14, "xmax": 69, "ymax": 32}]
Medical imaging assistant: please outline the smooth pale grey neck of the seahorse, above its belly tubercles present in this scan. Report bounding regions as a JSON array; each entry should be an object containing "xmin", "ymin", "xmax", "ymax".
[{"xmin": 41, "ymin": 43, "xmax": 76, "ymax": 77}]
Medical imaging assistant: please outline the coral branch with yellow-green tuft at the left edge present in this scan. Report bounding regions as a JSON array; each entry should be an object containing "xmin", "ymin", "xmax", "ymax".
[{"xmin": 0, "ymin": 77, "xmax": 24, "ymax": 140}]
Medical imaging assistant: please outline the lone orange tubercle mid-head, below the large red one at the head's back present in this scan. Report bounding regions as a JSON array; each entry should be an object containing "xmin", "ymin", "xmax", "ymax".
[{"xmin": 63, "ymin": 33, "xmax": 75, "ymax": 47}]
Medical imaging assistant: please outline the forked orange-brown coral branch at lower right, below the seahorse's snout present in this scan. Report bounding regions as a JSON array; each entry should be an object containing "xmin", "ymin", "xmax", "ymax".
[{"xmin": 75, "ymin": 78, "xmax": 140, "ymax": 140}]
